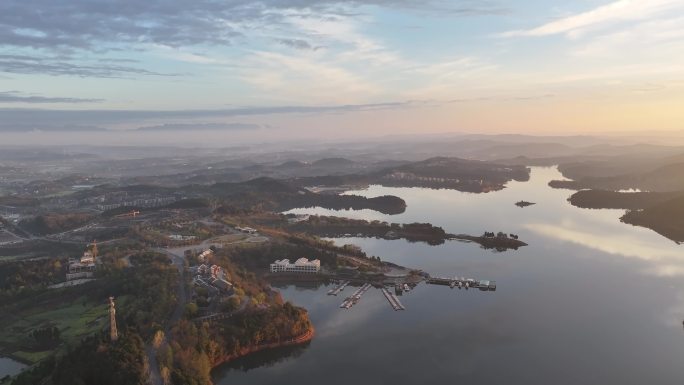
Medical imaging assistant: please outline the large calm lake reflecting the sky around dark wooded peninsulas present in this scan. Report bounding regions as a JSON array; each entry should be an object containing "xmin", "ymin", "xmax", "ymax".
[{"xmin": 213, "ymin": 168, "xmax": 684, "ymax": 385}]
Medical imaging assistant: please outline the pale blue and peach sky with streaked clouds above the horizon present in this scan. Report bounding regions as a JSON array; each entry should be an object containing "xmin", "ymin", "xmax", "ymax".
[{"xmin": 0, "ymin": 0, "xmax": 684, "ymax": 144}]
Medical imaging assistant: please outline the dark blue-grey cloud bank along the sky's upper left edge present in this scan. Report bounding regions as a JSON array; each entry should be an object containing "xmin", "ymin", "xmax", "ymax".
[{"xmin": 0, "ymin": 0, "xmax": 501, "ymax": 51}]
